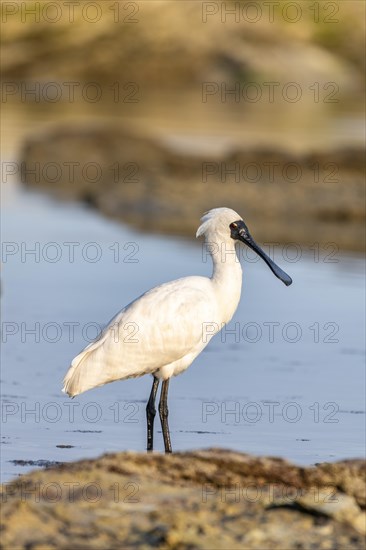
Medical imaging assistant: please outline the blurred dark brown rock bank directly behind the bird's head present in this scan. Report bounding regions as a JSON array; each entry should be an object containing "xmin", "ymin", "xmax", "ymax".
[{"xmin": 20, "ymin": 123, "xmax": 366, "ymax": 253}]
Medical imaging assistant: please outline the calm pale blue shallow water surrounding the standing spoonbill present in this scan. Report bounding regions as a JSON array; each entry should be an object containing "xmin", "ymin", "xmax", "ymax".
[{"xmin": 1, "ymin": 178, "xmax": 365, "ymax": 481}]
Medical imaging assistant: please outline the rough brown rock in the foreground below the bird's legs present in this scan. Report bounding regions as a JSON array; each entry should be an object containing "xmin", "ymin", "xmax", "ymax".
[{"xmin": 1, "ymin": 449, "xmax": 366, "ymax": 550}]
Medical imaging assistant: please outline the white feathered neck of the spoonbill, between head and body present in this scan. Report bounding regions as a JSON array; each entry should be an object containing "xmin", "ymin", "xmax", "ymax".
[{"xmin": 206, "ymin": 239, "xmax": 243, "ymax": 323}]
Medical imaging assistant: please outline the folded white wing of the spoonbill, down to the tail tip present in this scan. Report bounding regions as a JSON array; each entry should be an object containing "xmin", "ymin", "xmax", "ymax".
[{"xmin": 64, "ymin": 277, "xmax": 217, "ymax": 396}]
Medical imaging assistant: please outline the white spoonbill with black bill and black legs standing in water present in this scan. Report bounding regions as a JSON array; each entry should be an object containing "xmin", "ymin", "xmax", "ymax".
[{"xmin": 63, "ymin": 208, "xmax": 292, "ymax": 453}]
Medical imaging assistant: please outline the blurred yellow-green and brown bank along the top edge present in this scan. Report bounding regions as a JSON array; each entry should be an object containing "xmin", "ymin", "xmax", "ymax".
[{"xmin": 1, "ymin": 0, "xmax": 365, "ymax": 90}]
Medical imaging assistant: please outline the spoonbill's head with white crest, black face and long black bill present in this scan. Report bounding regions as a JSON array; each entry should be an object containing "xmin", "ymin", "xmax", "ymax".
[{"xmin": 196, "ymin": 208, "xmax": 292, "ymax": 286}]
